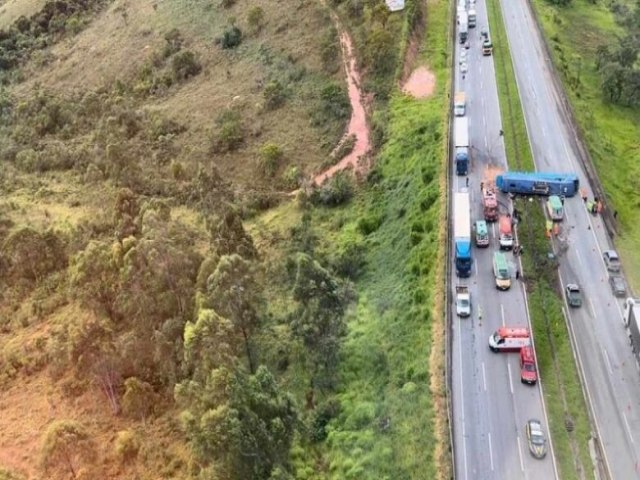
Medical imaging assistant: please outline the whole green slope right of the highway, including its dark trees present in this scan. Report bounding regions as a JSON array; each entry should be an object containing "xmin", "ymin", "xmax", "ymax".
[{"xmin": 533, "ymin": 0, "xmax": 640, "ymax": 291}]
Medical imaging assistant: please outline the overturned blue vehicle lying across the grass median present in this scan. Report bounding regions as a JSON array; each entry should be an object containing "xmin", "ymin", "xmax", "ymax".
[{"xmin": 496, "ymin": 172, "xmax": 580, "ymax": 197}]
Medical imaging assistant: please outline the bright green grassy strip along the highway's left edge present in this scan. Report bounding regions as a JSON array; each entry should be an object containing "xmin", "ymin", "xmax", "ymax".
[{"xmin": 318, "ymin": 2, "xmax": 449, "ymax": 479}]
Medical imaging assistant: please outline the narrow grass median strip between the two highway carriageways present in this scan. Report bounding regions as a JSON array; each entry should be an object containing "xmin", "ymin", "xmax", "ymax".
[{"xmin": 487, "ymin": 0, "xmax": 592, "ymax": 479}]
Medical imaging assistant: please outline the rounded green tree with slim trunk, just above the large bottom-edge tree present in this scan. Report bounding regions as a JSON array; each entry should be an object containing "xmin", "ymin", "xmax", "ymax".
[{"xmin": 207, "ymin": 254, "xmax": 259, "ymax": 373}]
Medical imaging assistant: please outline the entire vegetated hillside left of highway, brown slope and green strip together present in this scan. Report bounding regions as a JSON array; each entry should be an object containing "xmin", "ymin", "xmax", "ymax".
[{"xmin": 0, "ymin": 0, "xmax": 448, "ymax": 479}]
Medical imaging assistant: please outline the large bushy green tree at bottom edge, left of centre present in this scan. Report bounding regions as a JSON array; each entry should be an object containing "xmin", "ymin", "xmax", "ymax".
[{"xmin": 178, "ymin": 366, "xmax": 297, "ymax": 480}]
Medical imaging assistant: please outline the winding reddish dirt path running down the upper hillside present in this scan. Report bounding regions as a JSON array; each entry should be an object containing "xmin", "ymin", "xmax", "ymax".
[{"xmin": 313, "ymin": 24, "xmax": 371, "ymax": 185}]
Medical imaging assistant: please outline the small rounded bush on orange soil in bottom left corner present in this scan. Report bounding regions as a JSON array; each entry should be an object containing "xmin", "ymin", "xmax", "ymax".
[{"xmin": 42, "ymin": 420, "xmax": 96, "ymax": 479}]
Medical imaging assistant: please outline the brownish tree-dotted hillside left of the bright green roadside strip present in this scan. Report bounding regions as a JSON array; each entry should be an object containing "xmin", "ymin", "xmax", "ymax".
[{"xmin": 0, "ymin": 0, "xmax": 430, "ymax": 480}]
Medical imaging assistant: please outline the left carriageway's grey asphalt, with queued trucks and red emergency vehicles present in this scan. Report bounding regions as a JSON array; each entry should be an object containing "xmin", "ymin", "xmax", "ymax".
[{"xmin": 449, "ymin": 1, "xmax": 556, "ymax": 480}]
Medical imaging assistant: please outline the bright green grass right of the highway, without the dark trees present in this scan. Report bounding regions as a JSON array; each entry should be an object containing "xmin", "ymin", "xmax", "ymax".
[{"xmin": 532, "ymin": 0, "xmax": 640, "ymax": 293}]
